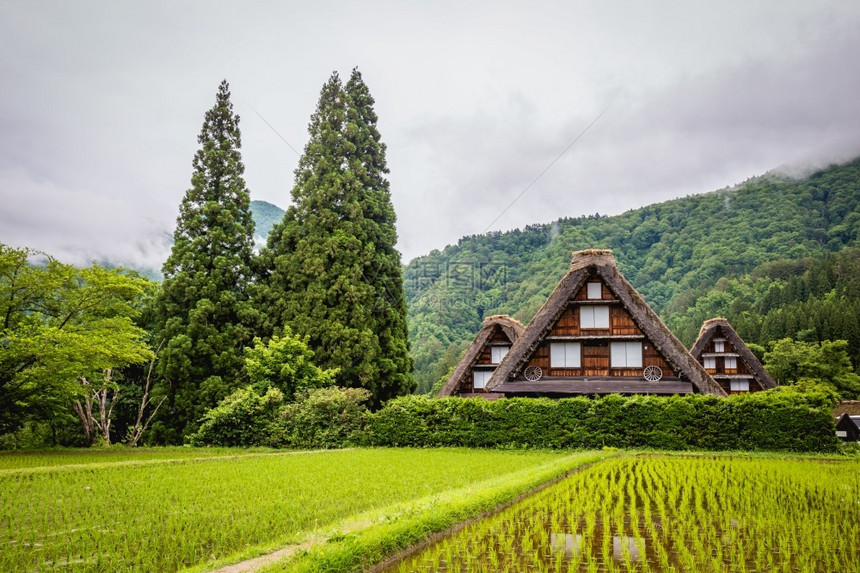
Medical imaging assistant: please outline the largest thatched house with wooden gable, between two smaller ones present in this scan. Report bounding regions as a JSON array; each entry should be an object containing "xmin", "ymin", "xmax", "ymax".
[{"xmin": 486, "ymin": 250, "xmax": 726, "ymax": 397}]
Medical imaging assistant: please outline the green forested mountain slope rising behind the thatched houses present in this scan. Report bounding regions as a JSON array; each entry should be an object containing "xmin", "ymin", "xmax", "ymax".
[{"xmin": 404, "ymin": 159, "xmax": 860, "ymax": 392}]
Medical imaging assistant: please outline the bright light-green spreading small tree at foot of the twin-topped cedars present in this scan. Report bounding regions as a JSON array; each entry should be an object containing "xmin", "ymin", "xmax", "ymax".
[{"xmin": 245, "ymin": 327, "xmax": 337, "ymax": 401}]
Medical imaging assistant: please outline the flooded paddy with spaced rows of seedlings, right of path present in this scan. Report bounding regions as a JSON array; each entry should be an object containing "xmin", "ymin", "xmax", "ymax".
[{"xmin": 384, "ymin": 456, "xmax": 860, "ymax": 573}]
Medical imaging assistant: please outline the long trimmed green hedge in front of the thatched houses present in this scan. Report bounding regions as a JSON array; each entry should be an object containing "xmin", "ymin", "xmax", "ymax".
[{"xmin": 358, "ymin": 389, "xmax": 839, "ymax": 452}]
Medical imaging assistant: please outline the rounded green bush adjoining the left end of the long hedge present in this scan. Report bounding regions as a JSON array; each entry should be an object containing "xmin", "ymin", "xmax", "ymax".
[{"xmin": 267, "ymin": 386, "xmax": 370, "ymax": 449}]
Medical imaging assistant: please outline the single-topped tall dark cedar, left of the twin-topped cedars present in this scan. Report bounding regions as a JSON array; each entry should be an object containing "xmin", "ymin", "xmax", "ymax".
[{"xmin": 154, "ymin": 80, "xmax": 256, "ymax": 442}]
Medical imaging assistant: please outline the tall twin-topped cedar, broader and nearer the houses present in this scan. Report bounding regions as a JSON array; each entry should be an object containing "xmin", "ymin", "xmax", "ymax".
[{"xmin": 261, "ymin": 70, "xmax": 415, "ymax": 405}]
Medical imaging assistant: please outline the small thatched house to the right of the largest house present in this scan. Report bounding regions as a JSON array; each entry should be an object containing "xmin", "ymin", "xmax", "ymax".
[{"xmin": 690, "ymin": 318, "xmax": 776, "ymax": 394}]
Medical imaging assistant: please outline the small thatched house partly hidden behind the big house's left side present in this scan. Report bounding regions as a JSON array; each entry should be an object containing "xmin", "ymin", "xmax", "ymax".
[{"xmin": 438, "ymin": 314, "xmax": 525, "ymax": 398}]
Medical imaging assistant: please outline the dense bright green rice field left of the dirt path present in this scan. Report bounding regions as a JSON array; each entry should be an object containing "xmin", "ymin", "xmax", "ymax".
[{"xmin": 0, "ymin": 448, "xmax": 585, "ymax": 572}]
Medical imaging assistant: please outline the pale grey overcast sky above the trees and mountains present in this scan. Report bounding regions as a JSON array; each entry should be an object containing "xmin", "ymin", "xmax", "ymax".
[{"xmin": 0, "ymin": 0, "xmax": 860, "ymax": 268}]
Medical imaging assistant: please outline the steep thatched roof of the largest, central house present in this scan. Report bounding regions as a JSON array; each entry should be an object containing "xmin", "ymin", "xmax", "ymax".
[{"xmin": 487, "ymin": 249, "xmax": 726, "ymax": 396}]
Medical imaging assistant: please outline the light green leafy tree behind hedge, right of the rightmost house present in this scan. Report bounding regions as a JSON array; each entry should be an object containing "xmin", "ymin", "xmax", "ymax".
[{"xmin": 764, "ymin": 338, "xmax": 860, "ymax": 400}]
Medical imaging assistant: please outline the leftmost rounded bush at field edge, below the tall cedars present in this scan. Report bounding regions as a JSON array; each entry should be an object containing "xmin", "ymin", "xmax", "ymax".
[{"xmin": 188, "ymin": 386, "xmax": 284, "ymax": 447}]
